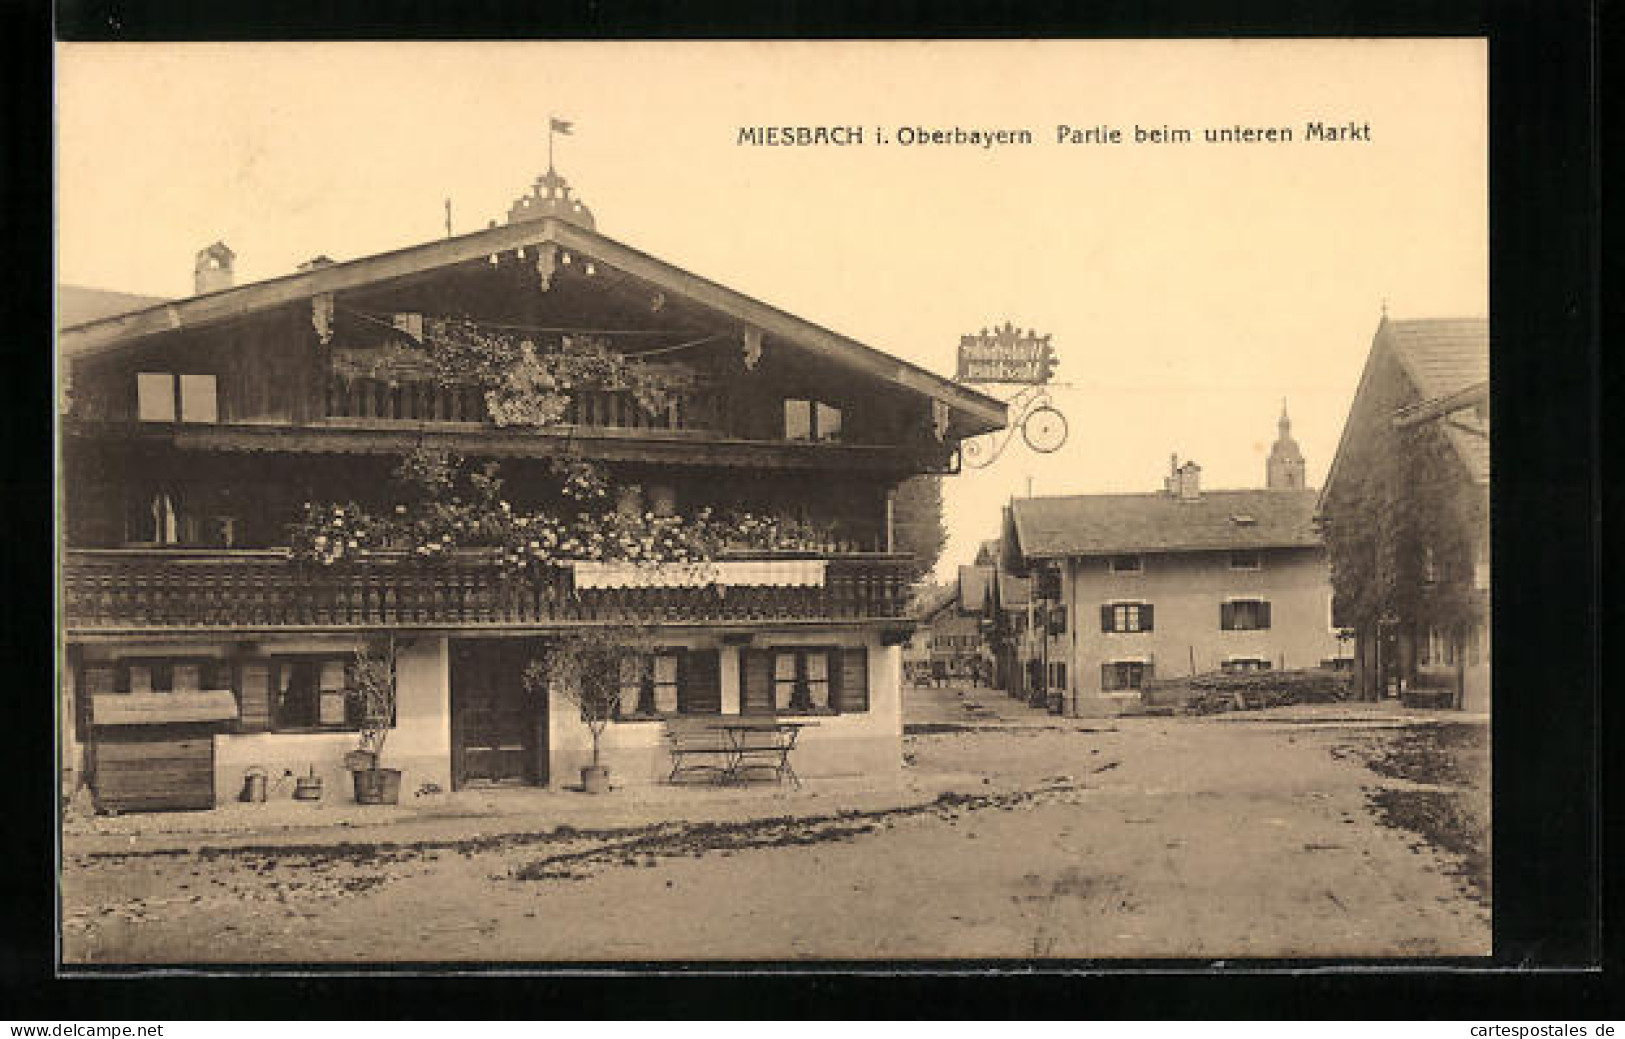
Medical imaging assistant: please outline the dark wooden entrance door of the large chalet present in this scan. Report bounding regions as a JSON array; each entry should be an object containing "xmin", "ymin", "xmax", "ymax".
[{"xmin": 452, "ymin": 639, "xmax": 548, "ymax": 789}]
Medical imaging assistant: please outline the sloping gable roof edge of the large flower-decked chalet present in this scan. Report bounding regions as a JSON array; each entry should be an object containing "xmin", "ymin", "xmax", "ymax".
[{"xmin": 57, "ymin": 216, "xmax": 1006, "ymax": 436}]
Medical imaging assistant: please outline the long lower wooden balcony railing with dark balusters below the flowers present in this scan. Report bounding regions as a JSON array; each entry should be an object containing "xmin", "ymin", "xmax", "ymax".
[{"xmin": 62, "ymin": 550, "xmax": 908, "ymax": 634}]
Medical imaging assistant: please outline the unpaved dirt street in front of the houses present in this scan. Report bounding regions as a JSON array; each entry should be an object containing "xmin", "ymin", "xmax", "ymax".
[{"xmin": 63, "ymin": 689, "xmax": 1490, "ymax": 964}]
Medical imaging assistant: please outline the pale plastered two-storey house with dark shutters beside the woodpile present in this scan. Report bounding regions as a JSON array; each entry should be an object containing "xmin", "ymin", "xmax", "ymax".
[{"xmin": 1006, "ymin": 409, "xmax": 1339, "ymax": 715}]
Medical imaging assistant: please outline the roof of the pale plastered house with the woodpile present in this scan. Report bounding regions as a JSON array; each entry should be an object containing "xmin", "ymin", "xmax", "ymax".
[{"xmin": 1012, "ymin": 489, "xmax": 1321, "ymax": 559}]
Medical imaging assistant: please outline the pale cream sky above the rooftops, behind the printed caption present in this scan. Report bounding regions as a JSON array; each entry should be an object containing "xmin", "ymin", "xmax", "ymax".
[{"xmin": 57, "ymin": 41, "xmax": 1489, "ymax": 576}]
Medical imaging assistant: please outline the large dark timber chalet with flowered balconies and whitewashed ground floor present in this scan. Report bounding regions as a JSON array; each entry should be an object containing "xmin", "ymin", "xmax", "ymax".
[{"xmin": 59, "ymin": 169, "xmax": 1004, "ymax": 808}]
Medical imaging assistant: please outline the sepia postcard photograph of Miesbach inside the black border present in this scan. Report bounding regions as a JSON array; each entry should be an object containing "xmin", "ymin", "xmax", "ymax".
[{"xmin": 55, "ymin": 37, "xmax": 1488, "ymax": 974}]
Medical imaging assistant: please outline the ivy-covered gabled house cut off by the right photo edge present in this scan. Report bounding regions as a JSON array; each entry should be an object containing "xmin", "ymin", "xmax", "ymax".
[{"xmin": 1318, "ymin": 314, "xmax": 1490, "ymax": 711}]
